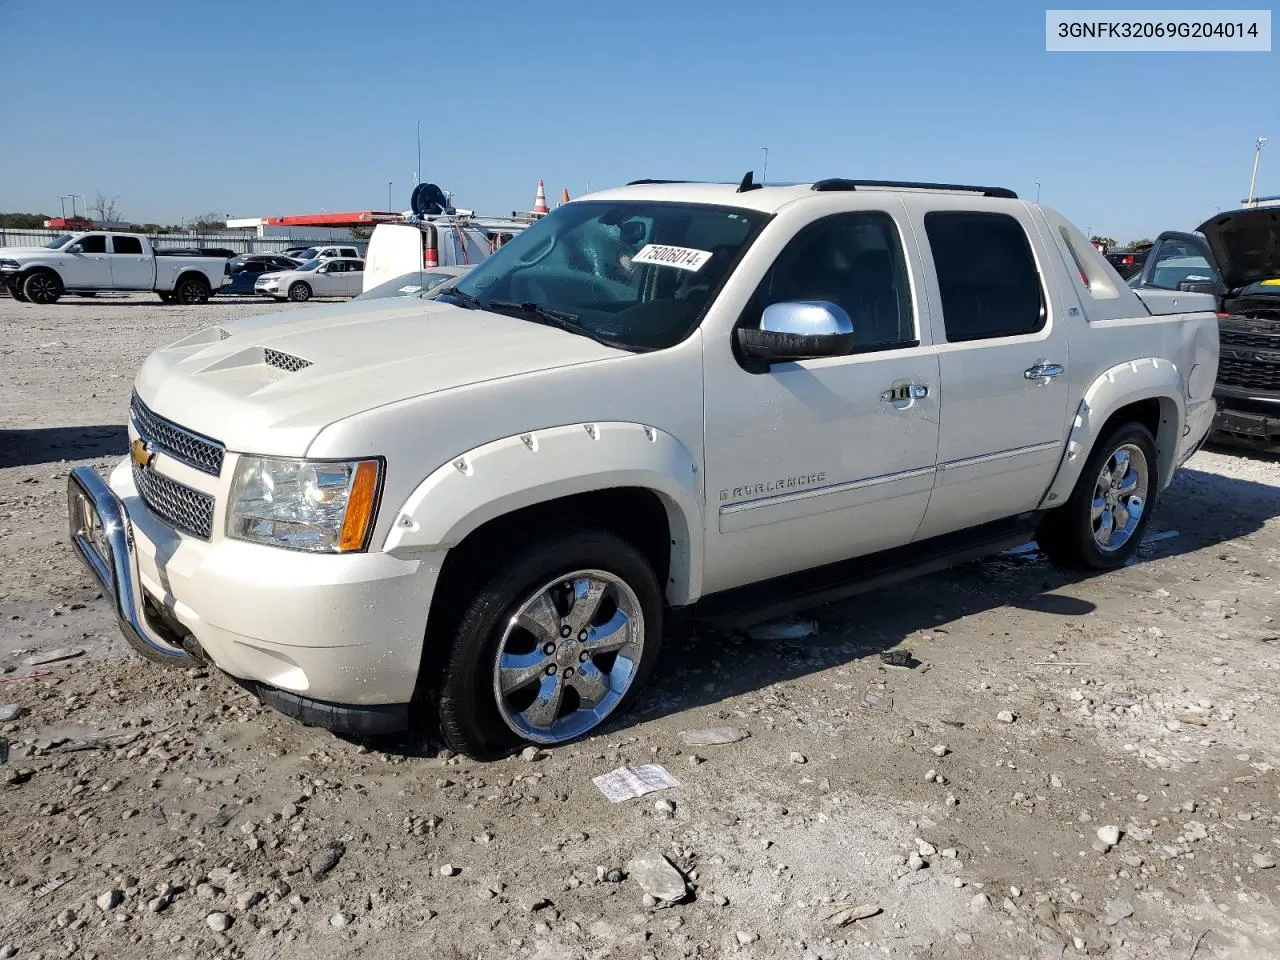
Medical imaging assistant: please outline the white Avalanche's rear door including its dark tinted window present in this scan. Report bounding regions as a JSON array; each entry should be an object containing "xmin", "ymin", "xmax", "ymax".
[{"xmin": 918, "ymin": 209, "xmax": 1083, "ymax": 539}]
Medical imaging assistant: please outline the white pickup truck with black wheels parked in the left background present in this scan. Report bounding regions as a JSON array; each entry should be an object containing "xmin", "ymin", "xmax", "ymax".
[{"xmin": 0, "ymin": 230, "xmax": 227, "ymax": 303}]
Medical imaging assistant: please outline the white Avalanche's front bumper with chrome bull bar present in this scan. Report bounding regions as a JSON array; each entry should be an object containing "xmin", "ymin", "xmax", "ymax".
[{"xmin": 68, "ymin": 460, "xmax": 443, "ymax": 733}]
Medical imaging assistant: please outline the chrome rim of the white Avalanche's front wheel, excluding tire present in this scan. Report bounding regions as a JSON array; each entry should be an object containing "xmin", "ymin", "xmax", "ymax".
[{"xmin": 493, "ymin": 570, "xmax": 645, "ymax": 744}]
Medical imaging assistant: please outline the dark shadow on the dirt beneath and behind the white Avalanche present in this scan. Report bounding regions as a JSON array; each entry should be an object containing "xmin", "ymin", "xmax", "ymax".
[{"xmin": 369, "ymin": 467, "xmax": 1280, "ymax": 756}]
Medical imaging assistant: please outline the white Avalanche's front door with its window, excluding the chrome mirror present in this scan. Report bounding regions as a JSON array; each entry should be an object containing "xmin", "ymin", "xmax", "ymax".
[{"xmin": 703, "ymin": 210, "xmax": 940, "ymax": 593}]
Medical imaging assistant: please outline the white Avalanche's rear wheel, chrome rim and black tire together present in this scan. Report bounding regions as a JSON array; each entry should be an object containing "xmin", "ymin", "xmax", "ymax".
[{"xmin": 1036, "ymin": 421, "xmax": 1160, "ymax": 570}]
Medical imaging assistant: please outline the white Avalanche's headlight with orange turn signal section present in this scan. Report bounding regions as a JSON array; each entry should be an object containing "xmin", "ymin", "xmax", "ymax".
[{"xmin": 227, "ymin": 457, "xmax": 383, "ymax": 553}]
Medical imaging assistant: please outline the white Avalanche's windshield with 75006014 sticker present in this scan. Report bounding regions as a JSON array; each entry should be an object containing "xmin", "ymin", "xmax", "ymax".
[{"xmin": 442, "ymin": 200, "xmax": 769, "ymax": 349}]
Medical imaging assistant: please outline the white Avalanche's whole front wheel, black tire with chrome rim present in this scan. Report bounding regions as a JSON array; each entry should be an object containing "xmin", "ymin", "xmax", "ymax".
[{"xmin": 435, "ymin": 529, "xmax": 662, "ymax": 759}]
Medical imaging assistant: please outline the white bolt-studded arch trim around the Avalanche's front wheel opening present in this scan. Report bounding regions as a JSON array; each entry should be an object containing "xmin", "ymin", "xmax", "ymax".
[{"xmin": 383, "ymin": 421, "xmax": 704, "ymax": 604}]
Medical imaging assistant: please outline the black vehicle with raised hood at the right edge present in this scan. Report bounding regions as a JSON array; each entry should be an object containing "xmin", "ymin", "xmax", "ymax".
[{"xmin": 1128, "ymin": 206, "xmax": 1280, "ymax": 451}]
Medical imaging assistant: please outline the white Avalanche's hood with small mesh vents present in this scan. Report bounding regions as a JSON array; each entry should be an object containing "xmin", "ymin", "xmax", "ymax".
[{"xmin": 136, "ymin": 297, "xmax": 628, "ymax": 457}]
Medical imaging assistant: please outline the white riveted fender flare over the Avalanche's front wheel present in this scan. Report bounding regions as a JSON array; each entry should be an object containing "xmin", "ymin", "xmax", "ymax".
[{"xmin": 384, "ymin": 422, "xmax": 703, "ymax": 604}]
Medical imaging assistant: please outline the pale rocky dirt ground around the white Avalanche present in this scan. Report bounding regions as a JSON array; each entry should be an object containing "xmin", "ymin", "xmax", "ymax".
[{"xmin": 0, "ymin": 297, "xmax": 1280, "ymax": 960}]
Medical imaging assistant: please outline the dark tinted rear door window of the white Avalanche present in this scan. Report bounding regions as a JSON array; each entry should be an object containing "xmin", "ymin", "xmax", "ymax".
[{"xmin": 924, "ymin": 211, "xmax": 1044, "ymax": 343}]
